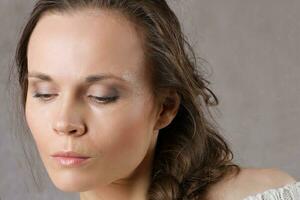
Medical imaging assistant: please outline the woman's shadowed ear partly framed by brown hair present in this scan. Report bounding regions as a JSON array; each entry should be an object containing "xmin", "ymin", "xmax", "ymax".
[{"xmin": 154, "ymin": 89, "xmax": 181, "ymax": 130}]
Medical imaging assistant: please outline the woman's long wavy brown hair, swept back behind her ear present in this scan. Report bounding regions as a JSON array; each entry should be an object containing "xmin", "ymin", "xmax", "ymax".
[{"xmin": 11, "ymin": 0, "xmax": 240, "ymax": 200}]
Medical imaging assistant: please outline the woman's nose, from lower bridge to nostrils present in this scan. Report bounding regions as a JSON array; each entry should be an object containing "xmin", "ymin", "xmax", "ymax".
[{"xmin": 52, "ymin": 96, "xmax": 86, "ymax": 137}]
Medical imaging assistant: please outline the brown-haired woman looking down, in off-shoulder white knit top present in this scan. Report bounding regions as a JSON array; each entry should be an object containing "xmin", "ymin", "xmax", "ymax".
[{"xmin": 11, "ymin": 0, "xmax": 300, "ymax": 200}]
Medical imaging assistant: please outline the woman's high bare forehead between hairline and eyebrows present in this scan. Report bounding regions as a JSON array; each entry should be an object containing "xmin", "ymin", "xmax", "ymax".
[{"xmin": 27, "ymin": 9, "xmax": 145, "ymax": 85}]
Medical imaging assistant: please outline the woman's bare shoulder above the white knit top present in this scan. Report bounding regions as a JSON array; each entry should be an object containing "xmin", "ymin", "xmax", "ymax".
[{"xmin": 208, "ymin": 168, "xmax": 296, "ymax": 200}]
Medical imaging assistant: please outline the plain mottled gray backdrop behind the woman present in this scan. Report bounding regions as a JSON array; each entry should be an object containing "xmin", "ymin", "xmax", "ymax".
[{"xmin": 0, "ymin": 0, "xmax": 300, "ymax": 200}]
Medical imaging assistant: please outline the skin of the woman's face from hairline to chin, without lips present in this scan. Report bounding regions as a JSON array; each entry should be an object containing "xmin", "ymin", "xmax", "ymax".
[{"xmin": 25, "ymin": 11, "xmax": 158, "ymax": 191}]
